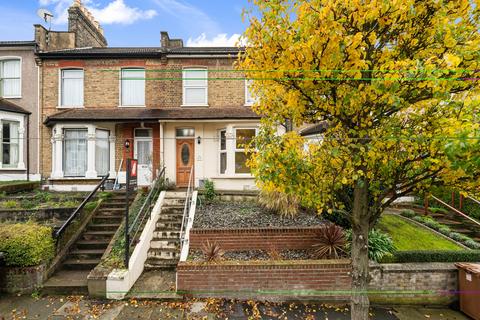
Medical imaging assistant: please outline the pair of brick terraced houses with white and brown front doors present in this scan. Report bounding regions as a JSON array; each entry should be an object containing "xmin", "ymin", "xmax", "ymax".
[{"xmin": 38, "ymin": 3, "xmax": 259, "ymax": 190}]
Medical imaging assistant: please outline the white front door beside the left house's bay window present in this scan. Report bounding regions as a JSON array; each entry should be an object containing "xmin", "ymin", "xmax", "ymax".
[{"xmin": 133, "ymin": 129, "xmax": 153, "ymax": 186}]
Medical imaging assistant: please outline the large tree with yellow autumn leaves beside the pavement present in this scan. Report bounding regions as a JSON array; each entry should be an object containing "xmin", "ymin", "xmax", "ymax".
[{"xmin": 238, "ymin": 0, "xmax": 480, "ymax": 319}]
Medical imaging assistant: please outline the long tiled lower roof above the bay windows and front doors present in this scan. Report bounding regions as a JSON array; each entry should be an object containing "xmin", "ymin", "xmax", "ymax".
[{"xmin": 44, "ymin": 107, "xmax": 260, "ymax": 126}]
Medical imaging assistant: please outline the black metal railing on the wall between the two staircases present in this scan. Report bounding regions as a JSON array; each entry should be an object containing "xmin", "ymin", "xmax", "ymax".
[{"xmin": 125, "ymin": 167, "xmax": 165, "ymax": 268}]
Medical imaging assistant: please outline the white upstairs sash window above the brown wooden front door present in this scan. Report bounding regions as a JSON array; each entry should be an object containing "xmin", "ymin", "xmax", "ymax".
[{"xmin": 183, "ymin": 68, "xmax": 208, "ymax": 106}]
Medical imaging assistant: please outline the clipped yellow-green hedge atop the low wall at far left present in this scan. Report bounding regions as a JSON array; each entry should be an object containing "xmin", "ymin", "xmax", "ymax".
[{"xmin": 0, "ymin": 223, "xmax": 55, "ymax": 267}]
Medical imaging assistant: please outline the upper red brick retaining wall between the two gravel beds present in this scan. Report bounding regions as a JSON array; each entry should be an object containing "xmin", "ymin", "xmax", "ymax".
[{"xmin": 190, "ymin": 227, "xmax": 319, "ymax": 250}]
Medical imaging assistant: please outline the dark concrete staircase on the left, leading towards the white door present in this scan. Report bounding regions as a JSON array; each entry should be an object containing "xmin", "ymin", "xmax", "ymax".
[{"xmin": 43, "ymin": 191, "xmax": 133, "ymax": 294}]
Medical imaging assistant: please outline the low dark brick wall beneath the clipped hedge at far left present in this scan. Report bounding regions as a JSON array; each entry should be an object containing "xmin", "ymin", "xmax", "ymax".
[{"xmin": 0, "ymin": 265, "xmax": 45, "ymax": 294}]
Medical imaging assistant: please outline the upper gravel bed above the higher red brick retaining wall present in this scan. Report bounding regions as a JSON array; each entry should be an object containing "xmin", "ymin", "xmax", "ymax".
[{"xmin": 193, "ymin": 202, "xmax": 324, "ymax": 229}]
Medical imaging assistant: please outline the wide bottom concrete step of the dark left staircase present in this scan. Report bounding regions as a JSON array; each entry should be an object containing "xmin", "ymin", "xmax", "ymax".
[{"xmin": 42, "ymin": 270, "xmax": 90, "ymax": 295}]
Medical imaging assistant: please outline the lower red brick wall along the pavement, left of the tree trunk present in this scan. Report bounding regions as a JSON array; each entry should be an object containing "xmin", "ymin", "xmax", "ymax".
[{"xmin": 177, "ymin": 260, "xmax": 351, "ymax": 300}]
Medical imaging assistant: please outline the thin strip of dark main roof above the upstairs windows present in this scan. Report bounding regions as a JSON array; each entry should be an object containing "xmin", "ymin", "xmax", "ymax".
[{"xmin": 38, "ymin": 47, "xmax": 243, "ymax": 59}]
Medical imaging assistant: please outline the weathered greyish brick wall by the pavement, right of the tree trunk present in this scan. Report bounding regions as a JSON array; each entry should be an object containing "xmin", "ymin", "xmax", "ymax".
[{"xmin": 370, "ymin": 263, "xmax": 458, "ymax": 305}]
